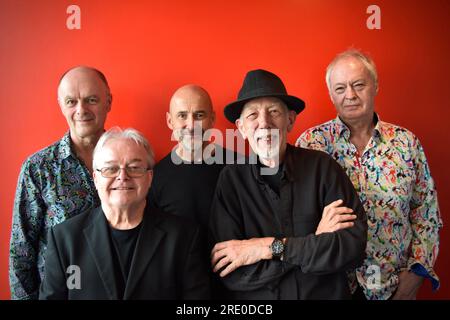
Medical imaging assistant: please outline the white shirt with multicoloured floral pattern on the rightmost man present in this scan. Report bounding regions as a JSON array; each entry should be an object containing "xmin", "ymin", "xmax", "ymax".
[{"xmin": 297, "ymin": 114, "xmax": 442, "ymax": 300}]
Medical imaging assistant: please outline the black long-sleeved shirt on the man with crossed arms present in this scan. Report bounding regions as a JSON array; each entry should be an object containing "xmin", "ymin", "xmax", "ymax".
[{"xmin": 210, "ymin": 145, "xmax": 367, "ymax": 299}]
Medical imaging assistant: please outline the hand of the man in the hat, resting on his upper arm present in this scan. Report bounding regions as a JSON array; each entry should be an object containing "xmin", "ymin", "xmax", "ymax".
[{"xmin": 316, "ymin": 200, "xmax": 356, "ymax": 236}]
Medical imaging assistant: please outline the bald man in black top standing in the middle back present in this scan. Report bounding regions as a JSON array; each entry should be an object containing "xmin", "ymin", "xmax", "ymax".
[{"xmin": 149, "ymin": 84, "xmax": 232, "ymax": 298}]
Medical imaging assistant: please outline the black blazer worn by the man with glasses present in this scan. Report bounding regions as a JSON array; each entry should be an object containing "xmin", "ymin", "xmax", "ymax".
[{"xmin": 39, "ymin": 207, "xmax": 209, "ymax": 300}]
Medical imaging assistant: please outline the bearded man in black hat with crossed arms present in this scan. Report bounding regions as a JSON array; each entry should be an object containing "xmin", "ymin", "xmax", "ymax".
[{"xmin": 210, "ymin": 70, "xmax": 367, "ymax": 299}]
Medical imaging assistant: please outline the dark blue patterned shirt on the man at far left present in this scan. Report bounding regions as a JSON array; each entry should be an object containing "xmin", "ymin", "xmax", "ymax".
[{"xmin": 9, "ymin": 133, "xmax": 100, "ymax": 299}]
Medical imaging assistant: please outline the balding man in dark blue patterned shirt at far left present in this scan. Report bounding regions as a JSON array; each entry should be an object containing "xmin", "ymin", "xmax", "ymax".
[{"xmin": 9, "ymin": 66, "xmax": 112, "ymax": 300}]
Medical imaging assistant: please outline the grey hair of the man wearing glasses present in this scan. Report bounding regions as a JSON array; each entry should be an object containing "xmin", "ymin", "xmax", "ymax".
[{"xmin": 92, "ymin": 127, "xmax": 155, "ymax": 169}]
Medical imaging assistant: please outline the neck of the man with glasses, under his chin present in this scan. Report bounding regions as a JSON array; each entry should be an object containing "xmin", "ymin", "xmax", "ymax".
[{"xmin": 102, "ymin": 200, "xmax": 146, "ymax": 230}]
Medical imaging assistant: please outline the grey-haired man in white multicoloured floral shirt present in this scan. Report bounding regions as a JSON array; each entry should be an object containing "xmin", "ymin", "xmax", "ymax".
[{"xmin": 297, "ymin": 50, "xmax": 442, "ymax": 300}]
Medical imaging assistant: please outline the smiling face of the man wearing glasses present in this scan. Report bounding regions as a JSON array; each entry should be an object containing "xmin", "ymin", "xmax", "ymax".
[{"xmin": 94, "ymin": 138, "xmax": 153, "ymax": 210}]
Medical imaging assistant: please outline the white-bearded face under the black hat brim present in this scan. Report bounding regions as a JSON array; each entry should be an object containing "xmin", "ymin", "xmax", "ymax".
[{"xmin": 236, "ymin": 97, "xmax": 296, "ymax": 161}]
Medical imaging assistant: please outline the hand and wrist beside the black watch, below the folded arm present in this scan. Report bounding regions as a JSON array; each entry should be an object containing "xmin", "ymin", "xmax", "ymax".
[{"xmin": 211, "ymin": 237, "xmax": 274, "ymax": 277}]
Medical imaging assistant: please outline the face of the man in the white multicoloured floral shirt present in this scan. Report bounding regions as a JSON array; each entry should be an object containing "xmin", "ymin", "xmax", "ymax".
[{"xmin": 330, "ymin": 56, "xmax": 377, "ymax": 123}]
